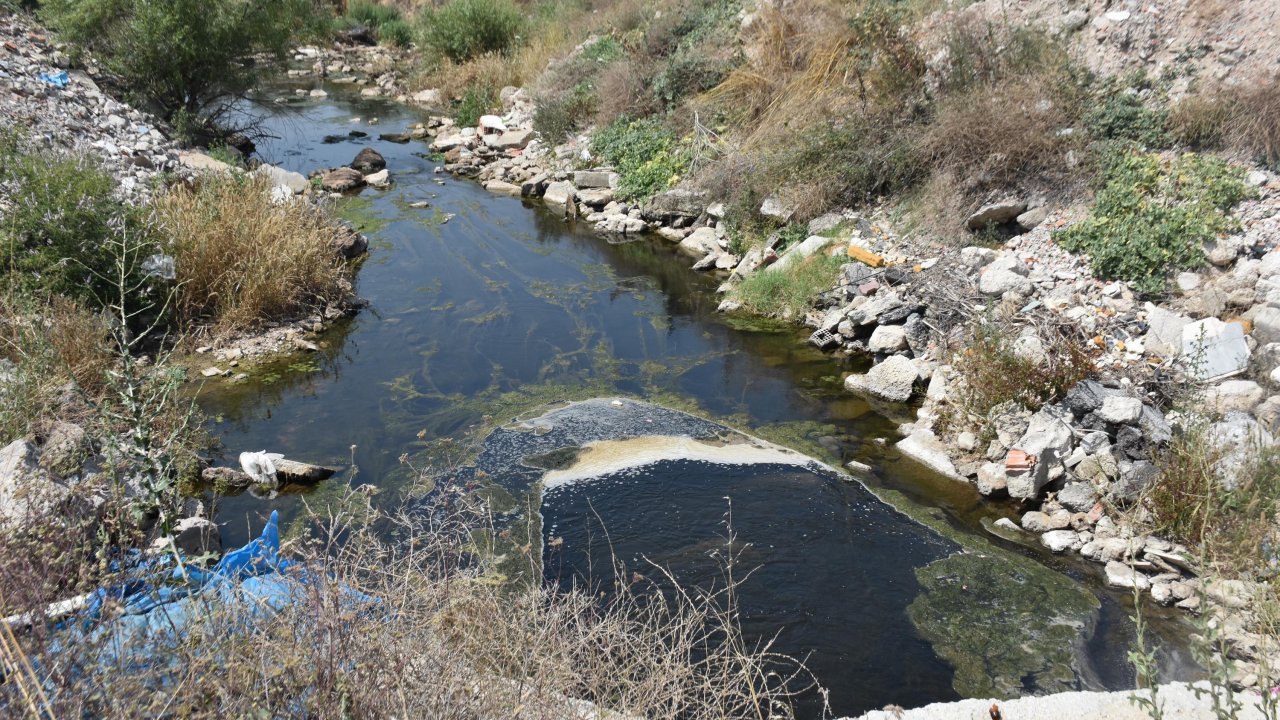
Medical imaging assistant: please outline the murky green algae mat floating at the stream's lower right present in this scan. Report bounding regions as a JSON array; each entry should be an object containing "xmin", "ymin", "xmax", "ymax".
[{"xmin": 908, "ymin": 552, "xmax": 1098, "ymax": 698}]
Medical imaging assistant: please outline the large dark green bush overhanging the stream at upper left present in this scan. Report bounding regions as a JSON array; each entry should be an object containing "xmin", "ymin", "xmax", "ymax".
[{"xmin": 41, "ymin": 0, "xmax": 320, "ymax": 129}]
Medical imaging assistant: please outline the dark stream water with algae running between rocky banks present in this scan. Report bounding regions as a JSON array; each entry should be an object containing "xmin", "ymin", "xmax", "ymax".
[{"xmin": 201, "ymin": 83, "xmax": 1190, "ymax": 717}]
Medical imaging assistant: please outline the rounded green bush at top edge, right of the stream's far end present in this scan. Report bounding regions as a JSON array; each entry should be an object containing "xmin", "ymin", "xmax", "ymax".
[{"xmin": 419, "ymin": 0, "xmax": 525, "ymax": 63}]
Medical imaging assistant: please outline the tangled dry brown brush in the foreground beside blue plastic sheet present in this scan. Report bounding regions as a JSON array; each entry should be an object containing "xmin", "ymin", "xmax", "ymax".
[{"xmin": 0, "ymin": 474, "xmax": 819, "ymax": 720}]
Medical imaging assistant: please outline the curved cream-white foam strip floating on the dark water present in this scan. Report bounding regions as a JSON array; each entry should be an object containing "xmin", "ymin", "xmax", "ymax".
[{"xmin": 543, "ymin": 436, "xmax": 813, "ymax": 489}]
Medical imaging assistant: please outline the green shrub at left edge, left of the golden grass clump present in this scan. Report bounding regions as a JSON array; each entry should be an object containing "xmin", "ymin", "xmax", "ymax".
[{"xmin": 0, "ymin": 138, "xmax": 157, "ymax": 307}]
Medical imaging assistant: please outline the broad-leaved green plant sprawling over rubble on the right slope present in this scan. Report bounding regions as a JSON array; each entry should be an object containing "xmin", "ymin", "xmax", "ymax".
[{"xmin": 1057, "ymin": 152, "xmax": 1251, "ymax": 293}]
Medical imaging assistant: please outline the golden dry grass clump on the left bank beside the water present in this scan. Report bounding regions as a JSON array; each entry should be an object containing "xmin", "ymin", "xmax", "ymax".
[{"xmin": 155, "ymin": 177, "xmax": 351, "ymax": 334}]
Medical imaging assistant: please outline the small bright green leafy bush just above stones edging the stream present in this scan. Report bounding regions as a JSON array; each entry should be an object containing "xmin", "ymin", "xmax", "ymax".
[{"xmin": 591, "ymin": 117, "xmax": 689, "ymax": 200}]
